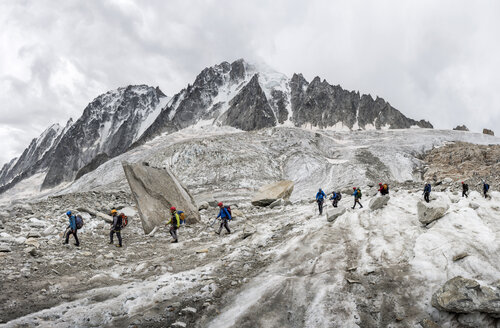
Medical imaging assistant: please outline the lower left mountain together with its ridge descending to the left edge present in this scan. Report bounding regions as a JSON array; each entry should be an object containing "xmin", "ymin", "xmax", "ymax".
[{"xmin": 0, "ymin": 85, "xmax": 170, "ymax": 192}]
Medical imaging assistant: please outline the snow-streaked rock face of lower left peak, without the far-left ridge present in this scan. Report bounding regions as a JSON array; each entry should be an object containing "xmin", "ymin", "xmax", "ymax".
[{"xmin": 42, "ymin": 85, "xmax": 164, "ymax": 188}]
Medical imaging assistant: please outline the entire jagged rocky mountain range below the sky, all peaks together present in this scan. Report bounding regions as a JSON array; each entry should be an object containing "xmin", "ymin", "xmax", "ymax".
[{"xmin": 0, "ymin": 59, "xmax": 432, "ymax": 193}]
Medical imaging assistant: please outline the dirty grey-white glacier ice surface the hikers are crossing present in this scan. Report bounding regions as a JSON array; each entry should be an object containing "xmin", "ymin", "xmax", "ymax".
[{"xmin": 0, "ymin": 128, "xmax": 500, "ymax": 327}]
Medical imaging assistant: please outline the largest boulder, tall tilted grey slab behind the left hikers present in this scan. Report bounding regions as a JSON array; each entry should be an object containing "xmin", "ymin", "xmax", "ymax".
[{"xmin": 122, "ymin": 162, "xmax": 200, "ymax": 234}]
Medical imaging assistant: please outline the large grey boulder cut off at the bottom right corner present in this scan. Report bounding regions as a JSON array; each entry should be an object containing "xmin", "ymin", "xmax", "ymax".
[{"xmin": 431, "ymin": 276, "xmax": 500, "ymax": 318}]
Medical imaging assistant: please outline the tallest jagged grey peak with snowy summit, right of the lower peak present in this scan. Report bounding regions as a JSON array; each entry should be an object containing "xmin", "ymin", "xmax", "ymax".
[{"xmin": 136, "ymin": 59, "xmax": 432, "ymax": 143}]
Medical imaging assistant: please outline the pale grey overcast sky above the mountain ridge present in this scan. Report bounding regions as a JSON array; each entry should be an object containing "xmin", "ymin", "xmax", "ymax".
[{"xmin": 0, "ymin": 0, "xmax": 500, "ymax": 165}]
